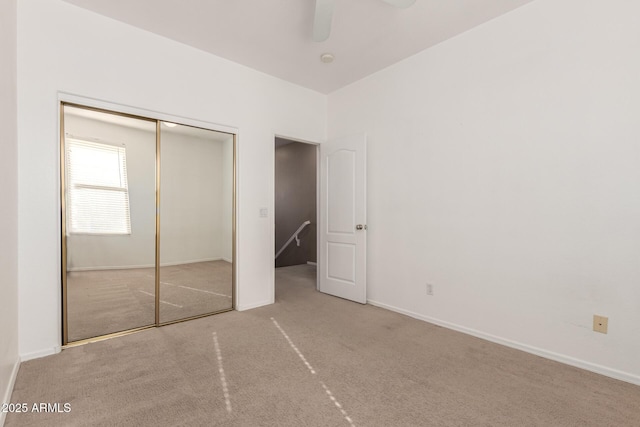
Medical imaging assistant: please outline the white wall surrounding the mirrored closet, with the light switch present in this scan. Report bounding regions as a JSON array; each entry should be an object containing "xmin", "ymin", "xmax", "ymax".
[{"xmin": 18, "ymin": 0, "xmax": 326, "ymax": 358}]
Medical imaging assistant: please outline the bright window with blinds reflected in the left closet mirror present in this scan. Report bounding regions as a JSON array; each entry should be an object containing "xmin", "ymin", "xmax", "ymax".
[{"xmin": 66, "ymin": 138, "xmax": 131, "ymax": 234}]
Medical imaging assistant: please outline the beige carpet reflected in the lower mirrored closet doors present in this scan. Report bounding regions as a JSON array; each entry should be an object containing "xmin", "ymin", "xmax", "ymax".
[{"xmin": 67, "ymin": 261, "xmax": 232, "ymax": 342}]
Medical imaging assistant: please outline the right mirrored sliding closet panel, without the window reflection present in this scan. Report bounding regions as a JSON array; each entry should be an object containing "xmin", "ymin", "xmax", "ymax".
[{"xmin": 159, "ymin": 123, "xmax": 234, "ymax": 323}]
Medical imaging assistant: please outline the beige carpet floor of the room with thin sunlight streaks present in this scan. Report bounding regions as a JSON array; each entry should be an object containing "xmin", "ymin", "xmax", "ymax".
[{"xmin": 6, "ymin": 266, "xmax": 640, "ymax": 427}]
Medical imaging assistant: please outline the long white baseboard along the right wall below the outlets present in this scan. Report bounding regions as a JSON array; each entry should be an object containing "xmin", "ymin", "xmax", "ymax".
[{"xmin": 367, "ymin": 300, "xmax": 640, "ymax": 385}]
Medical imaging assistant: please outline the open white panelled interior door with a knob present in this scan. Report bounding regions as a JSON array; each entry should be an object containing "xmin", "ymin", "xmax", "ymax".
[{"xmin": 318, "ymin": 134, "xmax": 367, "ymax": 304}]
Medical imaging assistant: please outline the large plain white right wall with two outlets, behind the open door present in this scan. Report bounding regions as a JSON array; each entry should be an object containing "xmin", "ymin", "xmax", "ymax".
[{"xmin": 328, "ymin": 0, "xmax": 640, "ymax": 383}]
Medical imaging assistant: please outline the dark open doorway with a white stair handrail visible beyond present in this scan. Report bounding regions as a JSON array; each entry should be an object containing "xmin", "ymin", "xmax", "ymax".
[{"xmin": 274, "ymin": 137, "xmax": 318, "ymax": 294}]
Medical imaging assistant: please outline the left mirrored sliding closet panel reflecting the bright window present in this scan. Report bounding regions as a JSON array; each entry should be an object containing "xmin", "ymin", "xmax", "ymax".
[{"xmin": 61, "ymin": 105, "xmax": 156, "ymax": 343}]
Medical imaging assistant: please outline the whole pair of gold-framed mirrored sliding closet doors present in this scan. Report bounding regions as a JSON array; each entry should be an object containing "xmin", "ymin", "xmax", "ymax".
[{"xmin": 61, "ymin": 104, "xmax": 235, "ymax": 345}]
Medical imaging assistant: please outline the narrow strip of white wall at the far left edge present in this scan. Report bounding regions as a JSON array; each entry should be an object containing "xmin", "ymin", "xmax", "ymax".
[{"xmin": 0, "ymin": 0, "xmax": 19, "ymax": 418}]
